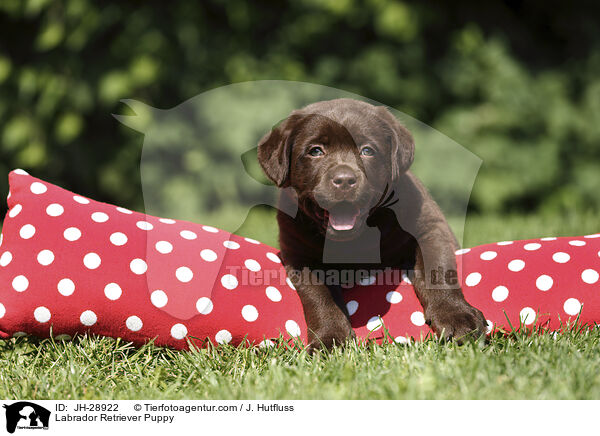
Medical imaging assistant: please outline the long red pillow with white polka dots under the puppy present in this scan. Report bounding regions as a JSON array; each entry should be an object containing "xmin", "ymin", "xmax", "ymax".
[{"xmin": 0, "ymin": 170, "xmax": 600, "ymax": 349}]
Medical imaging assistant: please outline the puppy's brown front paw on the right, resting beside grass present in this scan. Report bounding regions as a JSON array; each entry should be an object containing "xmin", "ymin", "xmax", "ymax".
[{"xmin": 425, "ymin": 299, "xmax": 487, "ymax": 343}]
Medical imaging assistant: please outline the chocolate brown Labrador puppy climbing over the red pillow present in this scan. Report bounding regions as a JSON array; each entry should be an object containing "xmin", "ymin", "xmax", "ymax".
[{"xmin": 258, "ymin": 99, "xmax": 486, "ymax": 351}]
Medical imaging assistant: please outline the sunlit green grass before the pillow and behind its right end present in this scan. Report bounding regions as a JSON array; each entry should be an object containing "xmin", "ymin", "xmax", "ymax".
[{"xmin": 0, "ymin": 210, "xmax": 600, "ymax": 399}]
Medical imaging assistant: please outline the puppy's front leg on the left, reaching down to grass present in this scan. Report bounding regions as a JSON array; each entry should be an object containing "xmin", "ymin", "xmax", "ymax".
[{"xmin": 286, "ymin": 267, "xmax": 354, "ymax": 353}]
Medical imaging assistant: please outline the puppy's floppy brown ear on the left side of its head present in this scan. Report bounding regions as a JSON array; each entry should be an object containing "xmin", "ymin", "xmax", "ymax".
[{"xmin": 257, "ymin": 114, "xmax": 302, "ymax": 187}]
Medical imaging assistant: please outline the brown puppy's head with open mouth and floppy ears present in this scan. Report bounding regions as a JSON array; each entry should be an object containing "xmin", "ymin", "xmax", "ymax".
[{"xmin": 258, "ymin": 99, "xmax": 414, "ymax": 241}]
